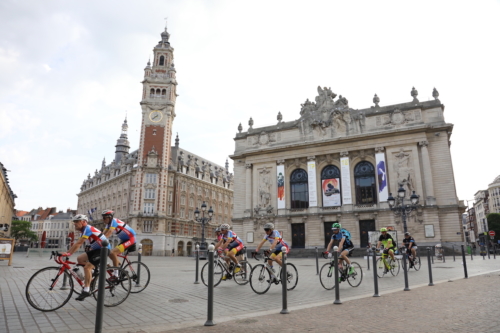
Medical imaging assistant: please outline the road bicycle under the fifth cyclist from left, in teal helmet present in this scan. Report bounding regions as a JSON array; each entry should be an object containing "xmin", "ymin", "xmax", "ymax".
[{"xmin": 319, "ymin": 253, "xmax": 363, "ymax": 290}]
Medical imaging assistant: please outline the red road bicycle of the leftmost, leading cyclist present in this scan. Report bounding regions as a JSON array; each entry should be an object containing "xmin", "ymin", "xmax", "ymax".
[{"xmin": 26, "ymin": 251, "xmax": 132, "ymax": 312}]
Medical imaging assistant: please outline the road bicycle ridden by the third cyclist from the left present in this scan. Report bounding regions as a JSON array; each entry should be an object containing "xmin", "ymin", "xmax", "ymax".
[{"xmin": 201, "ymin": 248, "xmax": 252, "ymax": 287}]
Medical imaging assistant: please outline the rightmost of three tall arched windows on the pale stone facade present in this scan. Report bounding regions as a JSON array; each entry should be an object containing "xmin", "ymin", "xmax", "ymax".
[{"xmin": 354, "ymin": 161, "xmax": 377, "ymax": 205}]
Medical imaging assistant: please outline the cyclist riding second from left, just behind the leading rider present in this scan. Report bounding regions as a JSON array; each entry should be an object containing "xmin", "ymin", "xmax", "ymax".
[{"xmin": 101, "ymin": 209, "xmax": 136, "ymax": 276}]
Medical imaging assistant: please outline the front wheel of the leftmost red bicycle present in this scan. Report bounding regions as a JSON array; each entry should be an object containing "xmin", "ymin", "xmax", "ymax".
[{"xmin": 26, "ymin": 267, "xmax": 73, "ymax": 312}]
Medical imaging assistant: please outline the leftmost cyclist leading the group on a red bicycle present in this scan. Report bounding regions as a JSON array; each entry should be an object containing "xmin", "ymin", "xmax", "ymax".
[{"xmin": 62, "ymin": 214, "xmax": 110, "ymax": 301}]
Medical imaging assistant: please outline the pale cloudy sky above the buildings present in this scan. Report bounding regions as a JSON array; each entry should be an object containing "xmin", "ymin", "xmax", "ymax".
[{"xmin": 0, "ymin": 0, "xmax": 500, "ymax": 210}]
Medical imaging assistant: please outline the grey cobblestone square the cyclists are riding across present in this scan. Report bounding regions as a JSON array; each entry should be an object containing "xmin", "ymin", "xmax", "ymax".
[{"xmin": 0, "ymin": 253, "xmax": 500, "ymax": 333}]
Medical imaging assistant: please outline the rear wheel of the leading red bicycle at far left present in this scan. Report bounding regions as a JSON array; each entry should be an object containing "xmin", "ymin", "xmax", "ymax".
[{"xmin": 90, "ymin": 267, "xmax": 132, "ymax": 307}]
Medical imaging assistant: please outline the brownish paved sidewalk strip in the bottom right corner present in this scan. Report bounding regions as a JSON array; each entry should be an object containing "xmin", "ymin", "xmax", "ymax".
[{"xmin": 161, "ymin": 272, "xmax": 500, "ymax": 333}]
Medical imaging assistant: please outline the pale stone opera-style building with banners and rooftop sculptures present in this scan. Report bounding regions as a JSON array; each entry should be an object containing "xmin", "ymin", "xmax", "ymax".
[{"xmin": 231, "ymin": 87, "xmax": 465, "ymax": 248}]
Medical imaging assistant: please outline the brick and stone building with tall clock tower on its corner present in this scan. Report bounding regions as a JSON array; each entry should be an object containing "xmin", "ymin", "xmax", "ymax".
[{"xmin": 78, "ymin": 28, "xmax": 233, "ymax": 255}]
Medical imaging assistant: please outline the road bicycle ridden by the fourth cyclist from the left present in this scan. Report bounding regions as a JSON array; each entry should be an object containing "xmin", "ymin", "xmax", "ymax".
[{"xmin": 250, "ymin": 250, "xmax": 299, "ymax": 294}]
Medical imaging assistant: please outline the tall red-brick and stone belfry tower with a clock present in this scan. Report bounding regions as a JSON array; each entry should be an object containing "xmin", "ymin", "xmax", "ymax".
[{"xmin": 131, "ymin": 28, "xmax": 177, "ymax": 233}]
